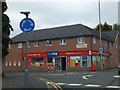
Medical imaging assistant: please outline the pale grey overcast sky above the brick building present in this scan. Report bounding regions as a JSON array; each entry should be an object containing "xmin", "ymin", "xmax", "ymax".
[{"xmin": 6, "ymin": 0, "xmax": 119, "ymax": 38}]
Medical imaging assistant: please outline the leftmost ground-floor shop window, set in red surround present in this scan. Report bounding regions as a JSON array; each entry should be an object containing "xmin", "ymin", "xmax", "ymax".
[{"xmin": 31, "ymin": 57, "xmax": 44, "ymax": 66}]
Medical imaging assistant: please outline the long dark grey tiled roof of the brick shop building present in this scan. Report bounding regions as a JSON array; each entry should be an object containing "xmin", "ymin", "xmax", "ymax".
[{"xmin": 12, "ymin": 24, "xmax": 116, "ymax": 42}]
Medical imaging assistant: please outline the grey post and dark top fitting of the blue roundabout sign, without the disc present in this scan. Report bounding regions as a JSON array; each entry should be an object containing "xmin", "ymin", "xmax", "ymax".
[{"xmin": 20, "ymin": 12, "xmax": 30, "ymax": 88}]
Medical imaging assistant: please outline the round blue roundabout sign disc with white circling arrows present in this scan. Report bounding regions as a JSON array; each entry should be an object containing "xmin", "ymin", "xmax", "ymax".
[{"xmin": 20, "ymin": 18, "xmax": 35, "ymax": 32}]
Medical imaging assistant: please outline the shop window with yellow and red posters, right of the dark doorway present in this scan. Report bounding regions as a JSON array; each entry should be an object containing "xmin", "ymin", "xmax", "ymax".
[{"xmin": 70, "ymin": 56, "xmax": 80, "ymax": 67}]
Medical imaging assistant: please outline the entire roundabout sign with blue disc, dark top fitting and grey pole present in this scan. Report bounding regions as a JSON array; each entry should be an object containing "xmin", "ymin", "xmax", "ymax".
[{"xmin": 20, "ymin": 12, "xmax": 35, "ymax": 88}]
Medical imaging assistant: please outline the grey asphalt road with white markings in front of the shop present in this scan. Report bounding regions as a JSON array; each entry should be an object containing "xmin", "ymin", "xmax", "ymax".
[{"xmin": 3, "ymin": 69, "xmax": 120, "ymax": 90}]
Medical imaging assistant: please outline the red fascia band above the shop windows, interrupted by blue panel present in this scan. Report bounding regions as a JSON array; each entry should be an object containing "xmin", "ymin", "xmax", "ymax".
[{"xmin": 22, "ymin": 50, "xmax": 111, "ymax": 66}]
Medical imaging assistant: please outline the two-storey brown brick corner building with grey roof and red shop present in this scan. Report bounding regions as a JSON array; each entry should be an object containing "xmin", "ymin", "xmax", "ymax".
[{"xmin": 5, "ymin": 24, "xmax": 120, "ymax": 71}]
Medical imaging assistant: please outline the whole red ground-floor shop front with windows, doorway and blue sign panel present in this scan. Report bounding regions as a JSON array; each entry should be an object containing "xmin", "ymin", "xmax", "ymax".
[{"xmin": 23, "ymin": 50, "xmax": 110, "ymax": 71}]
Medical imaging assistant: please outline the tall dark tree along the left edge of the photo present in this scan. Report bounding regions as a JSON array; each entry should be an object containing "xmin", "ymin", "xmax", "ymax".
[{"xmin": 2, "ymin": 2, "xmax": 13, "ymax": 76}]
